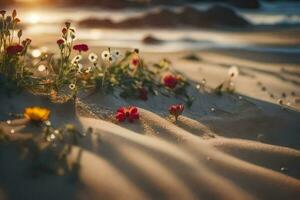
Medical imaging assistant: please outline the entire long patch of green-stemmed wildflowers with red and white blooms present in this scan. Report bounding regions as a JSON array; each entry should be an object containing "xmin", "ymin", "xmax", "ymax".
[{"xmin": 0, "ymin": 11, "xmax": 193, "ymax": 106}]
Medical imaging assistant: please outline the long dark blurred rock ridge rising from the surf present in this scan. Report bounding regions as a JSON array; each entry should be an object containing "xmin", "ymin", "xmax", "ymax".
[{"xmin": 78, "ymin": 5, "xmax": 250, "ymax": 28}]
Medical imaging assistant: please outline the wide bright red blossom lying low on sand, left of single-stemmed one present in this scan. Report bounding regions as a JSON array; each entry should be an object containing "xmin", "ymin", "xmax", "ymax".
[{"xmin": 115, "ymin": 106, "xmax": 140, "ymax": 123}]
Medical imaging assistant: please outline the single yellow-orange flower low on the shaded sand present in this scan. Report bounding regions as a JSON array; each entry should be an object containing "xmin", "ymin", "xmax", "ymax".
[{"xmin": 24, "ymin": 107, "xmax": 50, "ymax": 122}]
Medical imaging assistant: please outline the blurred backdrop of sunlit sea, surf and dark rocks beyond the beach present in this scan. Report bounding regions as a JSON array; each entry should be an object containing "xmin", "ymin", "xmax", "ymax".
[{"xmin": 0, "ymin": 0, "xmax": 300, "ymax": 52}]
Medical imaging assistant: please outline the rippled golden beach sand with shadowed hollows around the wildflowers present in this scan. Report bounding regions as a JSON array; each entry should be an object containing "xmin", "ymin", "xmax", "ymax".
[{"xmin": 0, "ymin": 27, "xmax": 300, "ymax": 200}]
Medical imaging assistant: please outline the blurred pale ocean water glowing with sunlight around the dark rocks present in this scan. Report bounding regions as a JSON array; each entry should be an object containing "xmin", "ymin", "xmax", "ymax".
[{"xmin": 5, "ymin": 2, "xmax": 300, "ymax": 53}]
